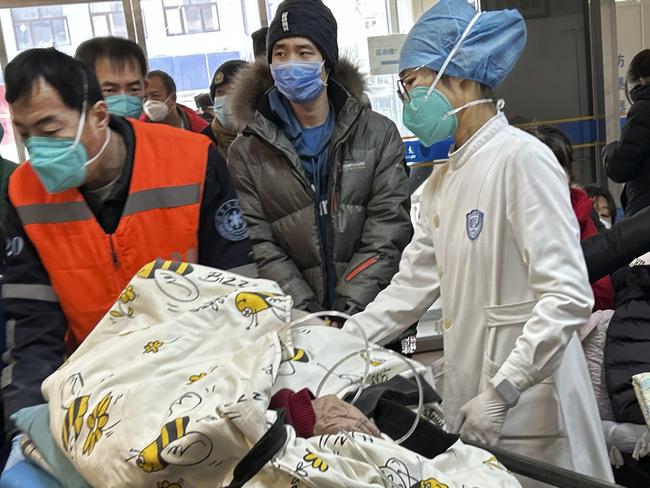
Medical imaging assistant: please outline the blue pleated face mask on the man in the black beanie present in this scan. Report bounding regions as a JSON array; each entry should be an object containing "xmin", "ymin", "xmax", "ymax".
[{"xmin": 271, "ymin": 61, "xmax": 327, "ymax": 104}]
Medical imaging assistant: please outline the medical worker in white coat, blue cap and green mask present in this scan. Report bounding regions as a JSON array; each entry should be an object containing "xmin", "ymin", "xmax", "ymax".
[{"xmin": 344, "ymin": 0, "xmax": 613, "ymax": 486}]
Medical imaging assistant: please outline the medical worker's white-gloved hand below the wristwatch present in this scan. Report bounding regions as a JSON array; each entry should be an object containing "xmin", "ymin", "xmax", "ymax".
[{"xmin": 460, "ymin": 383, "xmax": 509, "ymax": 446}]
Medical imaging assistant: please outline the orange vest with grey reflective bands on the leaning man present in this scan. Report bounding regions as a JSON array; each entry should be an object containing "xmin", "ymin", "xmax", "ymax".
[{"xmin": 9, "ymin": 120, "xmax": 210, "ymax": 346}]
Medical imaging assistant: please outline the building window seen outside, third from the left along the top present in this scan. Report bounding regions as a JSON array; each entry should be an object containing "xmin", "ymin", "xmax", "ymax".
[{"xmin": 162, "ymin": 0, "xmax": 221, "ymax": 36}]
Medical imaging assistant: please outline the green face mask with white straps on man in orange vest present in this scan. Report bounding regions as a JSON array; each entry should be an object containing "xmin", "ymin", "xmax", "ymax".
[{"xmin": 24, "ymin": 102, "xmax": 111, "ymax": 193}]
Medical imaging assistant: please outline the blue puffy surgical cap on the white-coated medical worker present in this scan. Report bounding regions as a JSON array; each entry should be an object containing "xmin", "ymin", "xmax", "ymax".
[{"xmin": 399, "ymin": 0, "xmax": 526, "ymax": 88}]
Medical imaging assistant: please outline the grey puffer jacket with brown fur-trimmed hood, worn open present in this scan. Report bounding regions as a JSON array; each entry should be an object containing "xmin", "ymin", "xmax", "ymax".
[{"xmin": 228, "ymin": 60, "xmax": 412, "ymax": 313}]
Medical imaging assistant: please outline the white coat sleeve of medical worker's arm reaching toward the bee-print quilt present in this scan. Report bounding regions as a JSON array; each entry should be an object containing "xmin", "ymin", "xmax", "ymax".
[{"xmin": 343, "ymin": 180, "xmax": 440, "ymax": 344}]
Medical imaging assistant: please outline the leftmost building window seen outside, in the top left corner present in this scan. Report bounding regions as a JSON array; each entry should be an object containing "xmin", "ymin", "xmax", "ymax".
[{"xmin": 11, "ymin": 6, "xmax": 70, "ymax": 51}]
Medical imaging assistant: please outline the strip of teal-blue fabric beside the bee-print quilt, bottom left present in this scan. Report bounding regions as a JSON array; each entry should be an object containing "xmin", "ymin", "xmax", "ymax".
[{"xmin": 11, "ymin": 403, "xmax": 90, "ymax": 488}]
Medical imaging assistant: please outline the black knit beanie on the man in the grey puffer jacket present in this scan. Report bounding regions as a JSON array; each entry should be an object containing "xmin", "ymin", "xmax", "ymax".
[{"xmin": 266, "ymin": 0, "xmax": 339, "ymax": 70}]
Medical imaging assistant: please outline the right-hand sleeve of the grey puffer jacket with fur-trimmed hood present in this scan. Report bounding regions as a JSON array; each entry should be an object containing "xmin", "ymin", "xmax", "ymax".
[{"xmin": 334, "ymin": 123, "xmax": 413, "ymax": 312}]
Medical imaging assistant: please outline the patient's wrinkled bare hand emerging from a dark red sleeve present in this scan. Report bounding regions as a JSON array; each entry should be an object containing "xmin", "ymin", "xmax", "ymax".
[{"xmin": 312, "ymin": 395, "xmax": 381, "ymax": 437}]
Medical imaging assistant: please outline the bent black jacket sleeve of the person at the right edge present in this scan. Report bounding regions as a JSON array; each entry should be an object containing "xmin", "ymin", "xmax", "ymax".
[{"xmin": 603, "ymin": 101, "xmax": 650, "ymax": 183}]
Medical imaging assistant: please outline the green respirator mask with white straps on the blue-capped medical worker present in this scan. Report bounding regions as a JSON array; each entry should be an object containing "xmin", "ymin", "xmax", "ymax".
[{"xmin": 402, "ymin": 12, "xmax": 494, "ymax": 146}]
